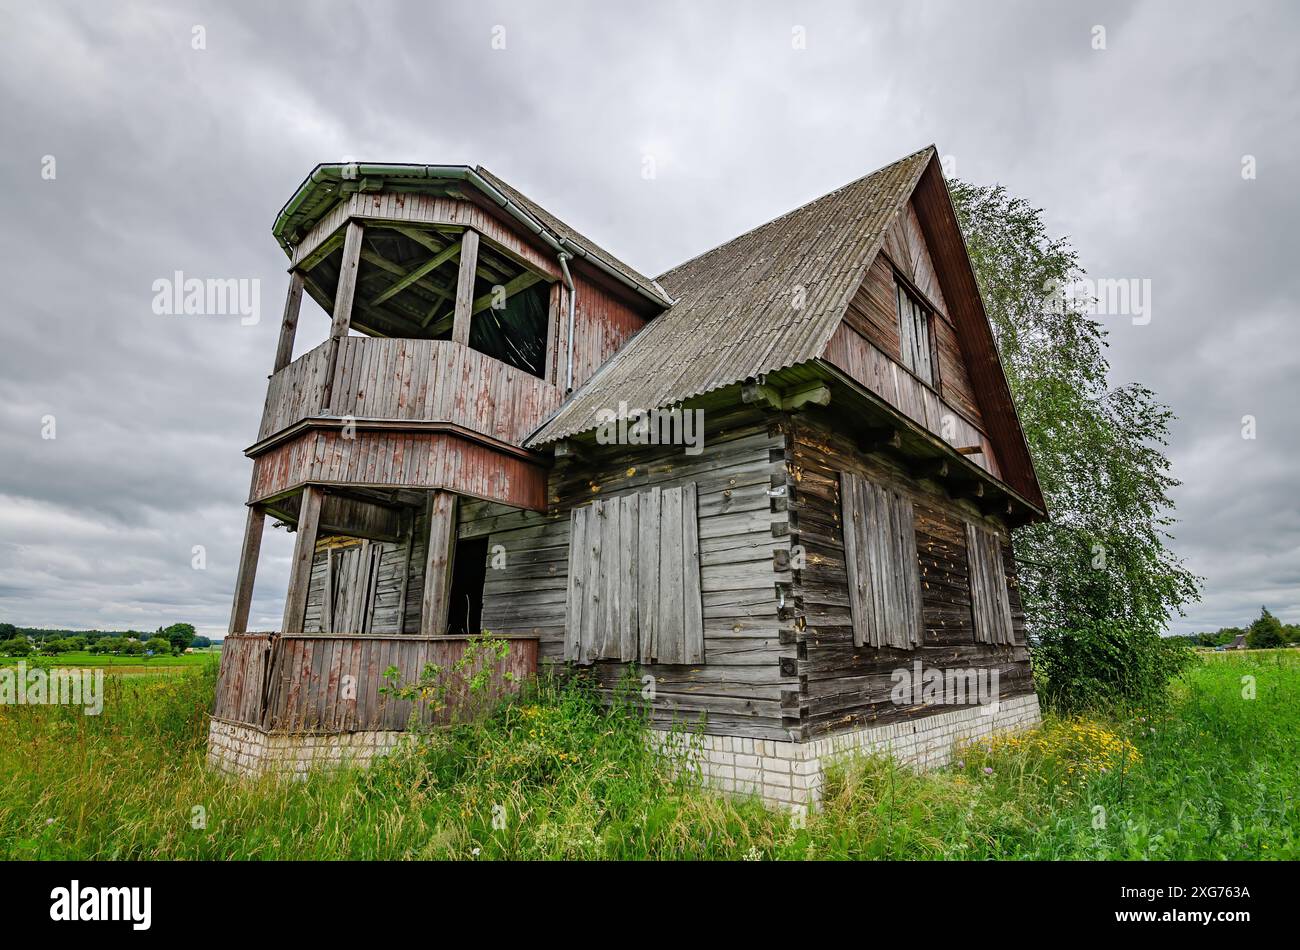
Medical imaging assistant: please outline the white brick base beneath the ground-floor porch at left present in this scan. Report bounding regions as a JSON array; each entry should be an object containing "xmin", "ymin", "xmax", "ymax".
[{"xmin": 208, "ymin": 719, "xmax": 404, "ymax": 778}]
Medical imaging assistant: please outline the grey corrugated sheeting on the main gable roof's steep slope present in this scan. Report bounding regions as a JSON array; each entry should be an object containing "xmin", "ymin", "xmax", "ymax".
[{"xmin": 529, "ymin": 147, "xmax": 933, "ymax": 446}]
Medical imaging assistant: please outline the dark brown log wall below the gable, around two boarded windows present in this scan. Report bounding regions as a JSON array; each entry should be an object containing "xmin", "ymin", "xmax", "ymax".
[{"xmin": 789, "ymin": 413, "xmax": 1034, "ymax": 738}]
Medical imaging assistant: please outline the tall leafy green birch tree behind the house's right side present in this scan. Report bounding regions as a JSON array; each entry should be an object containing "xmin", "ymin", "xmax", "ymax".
[{"xmin": 949, "ymin": 181, "xmax": 1200, "ymax": 712}]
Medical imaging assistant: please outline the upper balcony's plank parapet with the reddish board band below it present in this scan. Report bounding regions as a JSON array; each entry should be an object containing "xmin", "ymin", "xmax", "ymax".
[{"xmin": 247, "ymin": 337, "xmax": 563, "ymax": 508}]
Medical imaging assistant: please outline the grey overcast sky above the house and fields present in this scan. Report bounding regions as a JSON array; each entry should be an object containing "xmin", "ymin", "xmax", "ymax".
[{"xmin": 0, "ymin": 0, "xmax": 1300, "ymax": 633}]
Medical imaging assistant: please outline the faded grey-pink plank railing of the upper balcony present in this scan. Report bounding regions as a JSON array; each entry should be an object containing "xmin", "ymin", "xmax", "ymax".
[{"xmin": 257, "ymin": 337, "xmax": 564, "ymax": 444}]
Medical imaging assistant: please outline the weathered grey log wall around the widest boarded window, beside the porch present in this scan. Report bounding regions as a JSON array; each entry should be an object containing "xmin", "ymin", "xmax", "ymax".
[{"xmin": 458, "ymin": 409, "xmax": 796, "ymax": 739}]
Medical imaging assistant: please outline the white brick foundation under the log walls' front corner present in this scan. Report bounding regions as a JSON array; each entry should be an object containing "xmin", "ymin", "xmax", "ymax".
[{"xmin": 654, "ymin": 693, "xmax": 1043, "ymax": 807}]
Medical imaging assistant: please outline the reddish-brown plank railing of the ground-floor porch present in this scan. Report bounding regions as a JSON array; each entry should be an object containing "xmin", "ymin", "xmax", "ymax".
[{"xmin": 212, "ymin": 633, "xmax": 537, "ymax": 733}]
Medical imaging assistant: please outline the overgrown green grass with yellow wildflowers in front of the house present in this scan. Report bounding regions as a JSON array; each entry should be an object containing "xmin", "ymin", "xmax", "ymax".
[{"xmin": 0, "ymin": 651, "xmax": 1300, "ymax": 859}]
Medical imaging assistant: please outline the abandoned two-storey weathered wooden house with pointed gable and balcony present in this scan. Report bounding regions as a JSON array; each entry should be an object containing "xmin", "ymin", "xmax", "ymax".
[{"xmin": 209, "ymin": 147, "xmax": 1045, "ymax": 804}]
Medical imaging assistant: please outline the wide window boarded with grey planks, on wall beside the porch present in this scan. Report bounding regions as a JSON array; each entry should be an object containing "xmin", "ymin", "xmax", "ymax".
[{"xmin": 564, "ymin": 483, "xmax": 705, "ymax": 663}]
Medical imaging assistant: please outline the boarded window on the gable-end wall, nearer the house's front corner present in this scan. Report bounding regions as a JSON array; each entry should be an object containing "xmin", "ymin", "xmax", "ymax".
[{"xmin": 840, "ymin": 472, "xmax": 924, "ymax": 650}]
